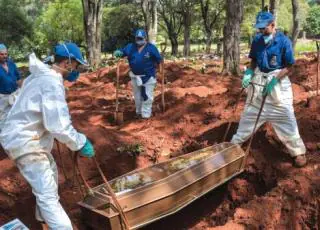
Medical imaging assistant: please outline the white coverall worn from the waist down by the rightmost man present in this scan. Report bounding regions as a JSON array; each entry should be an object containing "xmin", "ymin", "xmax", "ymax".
[{"xmin": 231, "ymin": 68, "xmax": 306, "ymax": 157}]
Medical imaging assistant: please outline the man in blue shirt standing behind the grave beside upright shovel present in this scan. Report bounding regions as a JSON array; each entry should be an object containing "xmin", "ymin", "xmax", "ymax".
[{"xmin": 114, "ymin": 29, "xmax": 163, "ymax": 118}]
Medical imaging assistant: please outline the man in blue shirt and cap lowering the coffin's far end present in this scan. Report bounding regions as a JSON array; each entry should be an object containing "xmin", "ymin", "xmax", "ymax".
[{"xmin": 231, "ymin": 12, "xmax": 307, "ymax": 167}]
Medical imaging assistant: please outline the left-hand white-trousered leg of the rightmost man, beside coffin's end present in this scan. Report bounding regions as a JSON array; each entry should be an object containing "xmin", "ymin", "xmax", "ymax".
[{"xmin": 231, "ymin": 105, "xmax": 266, "ymax": 144}]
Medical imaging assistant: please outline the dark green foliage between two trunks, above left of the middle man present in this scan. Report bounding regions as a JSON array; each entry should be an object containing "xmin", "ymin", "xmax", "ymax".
[{"xmin": 102, "ymin": 4, "xmax": 144, "ymax": 52}]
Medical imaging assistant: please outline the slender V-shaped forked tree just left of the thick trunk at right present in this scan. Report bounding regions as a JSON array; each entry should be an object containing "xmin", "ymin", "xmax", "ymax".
[{"xmin": 199, "ymin": 0, "xmax": 224, "ymax": 53}]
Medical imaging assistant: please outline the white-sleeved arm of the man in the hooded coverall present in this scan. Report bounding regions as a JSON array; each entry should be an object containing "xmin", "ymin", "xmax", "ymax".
[{"xmin": 42, "ymin": 82, "xmax": 87, "ymax": 151}]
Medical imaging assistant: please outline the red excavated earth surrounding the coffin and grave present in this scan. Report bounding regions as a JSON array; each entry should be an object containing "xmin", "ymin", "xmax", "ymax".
[{"xmin": 0, "ymin": 54, "xmax": 320, "ymax": 230}]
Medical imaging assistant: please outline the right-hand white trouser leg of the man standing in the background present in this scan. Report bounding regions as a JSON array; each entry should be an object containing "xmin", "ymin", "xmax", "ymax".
[{"xmin": 141, "ymin": 77, "xmax": 157, "ymax": 118}]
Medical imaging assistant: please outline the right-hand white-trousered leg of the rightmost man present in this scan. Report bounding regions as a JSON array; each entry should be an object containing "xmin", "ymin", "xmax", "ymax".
[{"xmin": 268, "ymin": 104, "xmax": 306, "ymax": 157}]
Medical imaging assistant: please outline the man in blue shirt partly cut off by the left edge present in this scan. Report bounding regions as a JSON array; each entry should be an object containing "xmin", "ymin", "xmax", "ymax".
[{"xmin": 0, "ymin": 44, "xmax": 21, "ymax": 131}]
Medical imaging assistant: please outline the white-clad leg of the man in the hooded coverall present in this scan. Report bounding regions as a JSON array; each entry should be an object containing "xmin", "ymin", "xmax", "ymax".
[{"xmin": 16, "ymin": 153, "xmax": 72, "ymax": 230}]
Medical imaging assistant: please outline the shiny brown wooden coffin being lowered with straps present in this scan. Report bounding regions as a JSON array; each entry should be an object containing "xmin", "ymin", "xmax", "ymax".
[{"xmin": 79, "ymin": 142, "xmax": 245, "ymax": 230}]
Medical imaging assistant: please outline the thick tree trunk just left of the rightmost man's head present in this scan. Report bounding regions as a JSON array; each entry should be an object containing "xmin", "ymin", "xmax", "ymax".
[{"xmin": 223, "ymin": 0, "xmax": 243, "ymax": 75}]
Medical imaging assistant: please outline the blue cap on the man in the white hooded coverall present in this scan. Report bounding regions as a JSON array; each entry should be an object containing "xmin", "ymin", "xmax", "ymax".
[{"xmin": 54, "ymin": 42, "xmax": 88, "ymax": 65}]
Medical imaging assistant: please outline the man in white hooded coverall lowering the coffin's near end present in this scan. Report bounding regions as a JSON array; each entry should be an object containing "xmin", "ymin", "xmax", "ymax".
[{"xmin": 0, "ymin": 43, "xmax": 95, "ymax": 230}]
